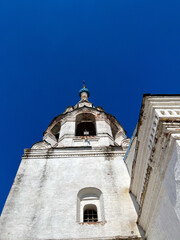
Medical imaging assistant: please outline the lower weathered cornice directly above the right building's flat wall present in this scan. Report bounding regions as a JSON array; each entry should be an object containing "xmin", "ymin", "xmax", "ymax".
[{"xmin": 138, "ymin": 120, "xmax": 180, "ymax": 230}]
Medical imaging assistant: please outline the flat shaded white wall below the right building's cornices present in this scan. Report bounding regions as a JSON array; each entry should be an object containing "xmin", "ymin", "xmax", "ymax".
[{"xmin": 148, "ymin": 140, "xmax": 180, "ymax": 240}]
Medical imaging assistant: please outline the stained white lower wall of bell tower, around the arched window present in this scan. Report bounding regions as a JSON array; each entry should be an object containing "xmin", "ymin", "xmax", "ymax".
[{"xmin": 0, "ymin": 149, "xmax": 139, "ymax": 240}]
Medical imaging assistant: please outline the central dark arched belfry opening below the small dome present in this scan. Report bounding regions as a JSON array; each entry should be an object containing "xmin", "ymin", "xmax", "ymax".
[{"xmin": 76, "ymin": 113, "xmax": 96, "ymax": 136}]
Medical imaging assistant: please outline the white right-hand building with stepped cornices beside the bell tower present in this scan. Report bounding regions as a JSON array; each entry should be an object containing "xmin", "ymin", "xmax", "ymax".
[{"xmin": 125, "ymin": 95, "xmax": 180, "ymax": 240}]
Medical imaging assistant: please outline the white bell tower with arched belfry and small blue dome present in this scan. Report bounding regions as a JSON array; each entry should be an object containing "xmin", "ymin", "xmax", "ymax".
[{"xmin": 0, "ymin": 84, "xmax": 142, "ymax": 240}]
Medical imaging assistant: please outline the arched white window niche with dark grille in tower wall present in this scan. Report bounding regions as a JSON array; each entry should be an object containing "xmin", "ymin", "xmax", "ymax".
[{"xmin": 77, "ymin": 187, "xmax": 105, "ymax": 223}]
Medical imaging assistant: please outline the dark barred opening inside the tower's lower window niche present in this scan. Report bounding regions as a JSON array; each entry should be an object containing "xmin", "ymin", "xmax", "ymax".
[{"xmin": 83, "ymin": 204, "xmax": 98, "ymax": 222}]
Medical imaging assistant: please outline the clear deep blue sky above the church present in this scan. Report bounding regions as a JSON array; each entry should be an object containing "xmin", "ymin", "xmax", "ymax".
[{"xmin": 0, "ymin": 0, "xmax": 180, "ymax": 214}]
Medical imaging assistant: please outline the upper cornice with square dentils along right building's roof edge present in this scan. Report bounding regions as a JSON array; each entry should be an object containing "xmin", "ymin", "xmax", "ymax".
[{"xmin": 131, "ymin": 96, "xmax": 180, "ymax": 203}]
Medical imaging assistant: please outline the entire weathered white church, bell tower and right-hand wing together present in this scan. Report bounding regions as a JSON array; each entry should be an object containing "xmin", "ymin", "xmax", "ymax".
[{"xmin": 0, "ymin": 85, "xmax": 180, "ymax": 240}]
